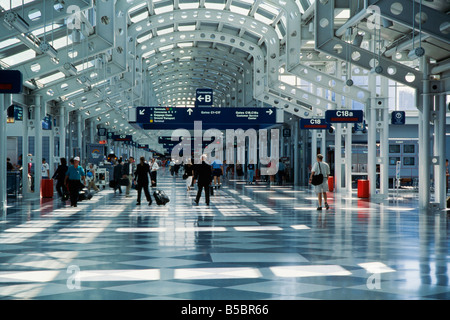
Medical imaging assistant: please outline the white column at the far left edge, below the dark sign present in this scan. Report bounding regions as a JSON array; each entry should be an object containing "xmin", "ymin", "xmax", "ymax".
[{"xmin": 0, "ymin": 94, "xmax": 12, "ymax": 220}]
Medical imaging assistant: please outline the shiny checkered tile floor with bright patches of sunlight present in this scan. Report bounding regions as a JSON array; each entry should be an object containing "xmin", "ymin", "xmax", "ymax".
[{"xmin": 0, "ymin": 170, "xmax": 450, "ymax": 300}]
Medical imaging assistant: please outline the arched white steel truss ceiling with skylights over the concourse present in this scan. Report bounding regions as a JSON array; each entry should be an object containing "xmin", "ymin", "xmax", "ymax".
[{"xmin": 0, "ymin": 0, "xmax": 448, "ymax": 151}]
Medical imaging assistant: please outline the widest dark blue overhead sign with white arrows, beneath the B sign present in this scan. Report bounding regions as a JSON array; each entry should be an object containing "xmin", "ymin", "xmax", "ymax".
[{"xmin": 136, "ymin": 107, "xmax": 277, "ymax": 130}]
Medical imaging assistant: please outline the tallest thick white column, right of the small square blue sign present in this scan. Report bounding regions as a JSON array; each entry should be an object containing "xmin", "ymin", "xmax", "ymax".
[{"xmin": 419, "ymin": 57, "xmax": 431, "ymax": 209}]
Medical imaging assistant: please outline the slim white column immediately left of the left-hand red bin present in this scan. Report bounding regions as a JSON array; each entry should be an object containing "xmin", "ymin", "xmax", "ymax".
[{"xmin": 33, "ymin": 96, "xmax": 43, "ymax": 198}]
